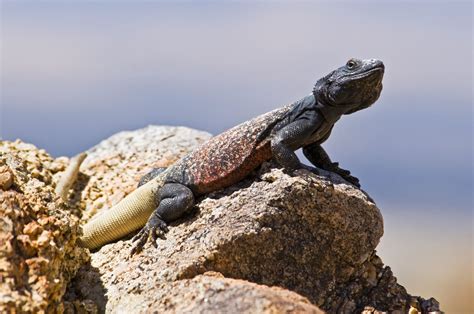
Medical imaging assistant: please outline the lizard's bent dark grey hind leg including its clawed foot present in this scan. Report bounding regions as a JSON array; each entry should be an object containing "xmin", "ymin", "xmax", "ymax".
[{"xmin": 131, "ymin": 183, "xmax": 195, "ymax": 255}]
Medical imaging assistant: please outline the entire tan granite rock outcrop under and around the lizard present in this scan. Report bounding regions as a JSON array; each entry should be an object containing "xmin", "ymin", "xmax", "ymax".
[{"xmin": 0, "ymin": 126, "xmax": 439, "ymax": 313}]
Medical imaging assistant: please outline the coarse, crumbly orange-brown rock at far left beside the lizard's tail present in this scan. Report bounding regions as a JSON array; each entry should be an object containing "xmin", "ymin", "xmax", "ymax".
[{"xmin": 0, "ymin": 141, "xmax": 88, "ymax": 313}]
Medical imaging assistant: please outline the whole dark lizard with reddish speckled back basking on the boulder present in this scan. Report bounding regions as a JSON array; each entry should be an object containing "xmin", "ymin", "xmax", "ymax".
[{"xmin": 80, "ymin": 59, "xmax": 384, "ymax": 254}]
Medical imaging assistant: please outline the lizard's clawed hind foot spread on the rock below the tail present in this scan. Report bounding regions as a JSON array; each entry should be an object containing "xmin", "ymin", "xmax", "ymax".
[{"xmin": 130, "ymin": 213, "xmax": 168, "ymax": 256}]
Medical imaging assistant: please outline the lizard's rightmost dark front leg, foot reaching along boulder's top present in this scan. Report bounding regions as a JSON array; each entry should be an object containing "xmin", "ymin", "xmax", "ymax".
[{"xmin": 303, "ymin": 143, "xmax": 360, "ymax": 188}]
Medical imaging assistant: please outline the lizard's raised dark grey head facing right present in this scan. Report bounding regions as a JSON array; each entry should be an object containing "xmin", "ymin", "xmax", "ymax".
[{"xmin": 313, "ymin": 59, "xmax": 385, "ymax": 114}]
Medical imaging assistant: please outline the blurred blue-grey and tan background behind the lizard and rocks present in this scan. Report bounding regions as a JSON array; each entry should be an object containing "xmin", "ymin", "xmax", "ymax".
[{"xmin": 0, "ymin": 1, "xmax": 474, "ymax": 313}]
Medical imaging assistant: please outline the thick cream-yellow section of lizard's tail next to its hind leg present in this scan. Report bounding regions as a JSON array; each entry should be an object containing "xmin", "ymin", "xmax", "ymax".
[{"xmin": 79, "ymin": 175, "xmax": 163, "ymax": 249}]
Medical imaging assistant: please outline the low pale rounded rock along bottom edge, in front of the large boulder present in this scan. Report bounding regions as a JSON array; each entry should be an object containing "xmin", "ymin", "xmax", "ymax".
[{"xmin": 68, "ymin": 272, "xmax": 323, "ymax": 314}]
